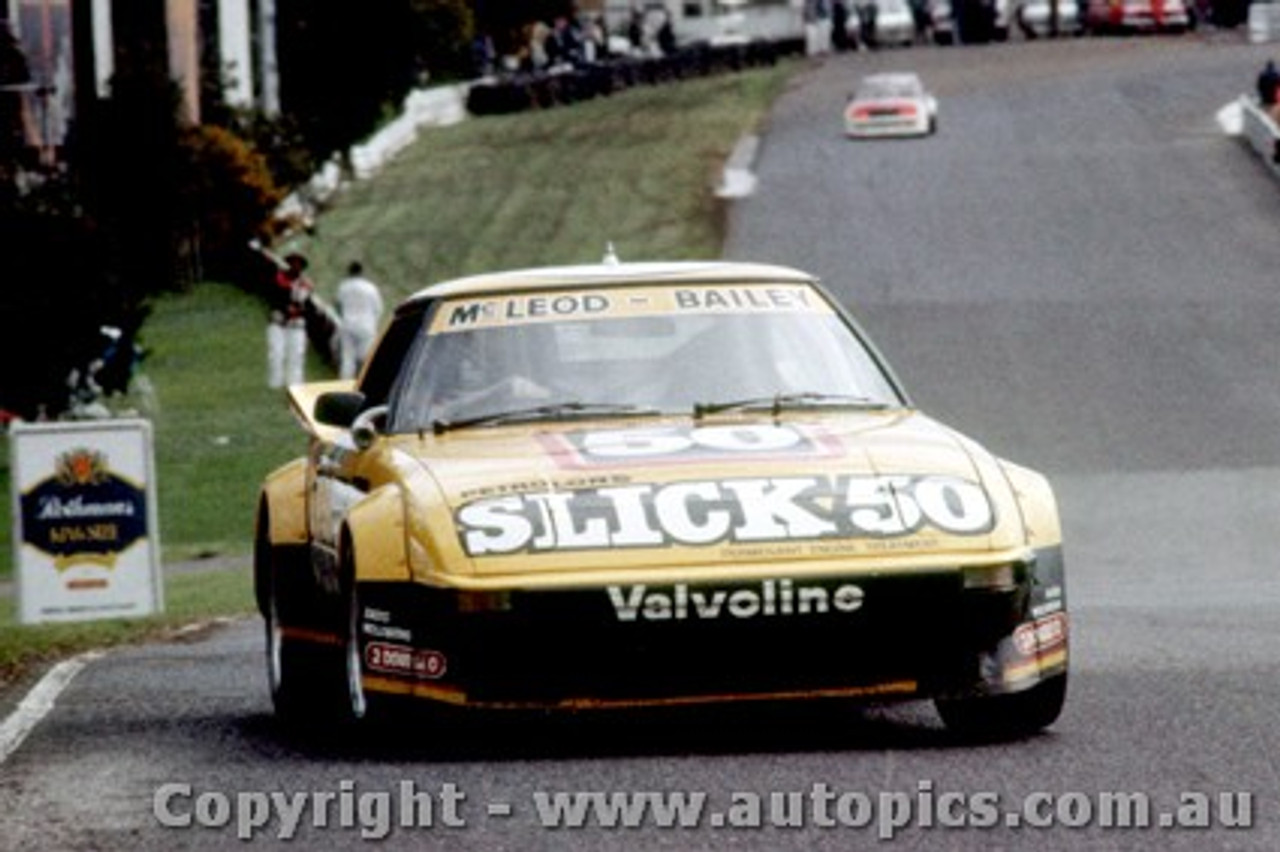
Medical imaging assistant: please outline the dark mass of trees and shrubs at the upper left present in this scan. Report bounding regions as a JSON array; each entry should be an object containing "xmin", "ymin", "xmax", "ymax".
[{"xmin": 0, "ymin": 0, "xmax": 474, "ymax": 417}]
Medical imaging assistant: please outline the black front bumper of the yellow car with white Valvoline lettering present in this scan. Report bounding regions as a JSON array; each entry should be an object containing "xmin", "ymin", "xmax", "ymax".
[{"xmin": 358, "ymin": 549, "xmax": 1066, "ymax": 707}]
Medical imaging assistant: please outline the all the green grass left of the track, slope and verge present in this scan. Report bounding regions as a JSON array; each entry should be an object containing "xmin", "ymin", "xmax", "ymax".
[{"xmin": 0, "ymin": 63, "xmax": 797, "ymax": 683}]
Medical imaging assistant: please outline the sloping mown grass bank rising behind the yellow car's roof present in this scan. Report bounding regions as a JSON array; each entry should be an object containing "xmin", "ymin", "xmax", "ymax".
[{"xmin": 294, "ymin": 67, "xmax": 801, "ymax": 305}]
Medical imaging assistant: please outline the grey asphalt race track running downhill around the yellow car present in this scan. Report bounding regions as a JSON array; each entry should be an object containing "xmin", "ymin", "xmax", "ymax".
[{"xmin": 0, "ymin": 32, "xmax": 1280, "ymax": 851}]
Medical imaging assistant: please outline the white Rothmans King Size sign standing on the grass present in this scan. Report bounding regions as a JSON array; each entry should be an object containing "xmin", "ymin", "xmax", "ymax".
[{"xmin": 10, "ymin": 420, "xmax": 164, "ymax": 624}]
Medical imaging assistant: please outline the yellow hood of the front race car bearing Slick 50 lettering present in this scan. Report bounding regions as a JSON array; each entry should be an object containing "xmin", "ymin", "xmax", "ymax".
[{"xmin": 399, "ymin": 411, "xmax": 1024, "ymax": 574}]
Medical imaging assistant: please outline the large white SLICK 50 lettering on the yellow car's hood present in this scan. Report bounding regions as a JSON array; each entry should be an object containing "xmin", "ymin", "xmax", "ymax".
[{"xmin": 454, "ymin": 475, "xmax": 996, "ymax": 556}]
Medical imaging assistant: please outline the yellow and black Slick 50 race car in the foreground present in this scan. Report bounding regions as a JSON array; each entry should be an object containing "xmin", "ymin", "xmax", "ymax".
[{"xmin": 255, "ymin": 262, "xmax": 1068, "ymax": 736}]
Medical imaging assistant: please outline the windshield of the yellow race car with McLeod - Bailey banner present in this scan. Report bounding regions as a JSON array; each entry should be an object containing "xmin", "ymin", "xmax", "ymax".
[{"xmin": 388, "ymin": 284, "xmax": 902, "ymax": 432}]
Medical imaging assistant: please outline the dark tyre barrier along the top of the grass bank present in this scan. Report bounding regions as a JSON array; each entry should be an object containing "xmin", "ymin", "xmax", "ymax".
[{"xmin": 466, "ymin": 40, "xmax": 804, "ymax": 116}]
